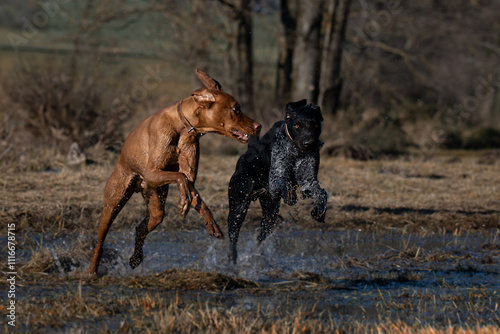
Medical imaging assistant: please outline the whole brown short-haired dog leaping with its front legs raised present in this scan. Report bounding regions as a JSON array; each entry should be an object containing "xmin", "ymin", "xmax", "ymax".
[{"xmin": 87, "ymin": 69, "xmax": 261, "ymax": 275}]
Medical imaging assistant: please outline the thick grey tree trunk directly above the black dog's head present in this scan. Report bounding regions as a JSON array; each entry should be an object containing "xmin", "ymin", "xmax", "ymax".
[{"xmin": 292, "ymin": 0, "xmax": 325, "ymax": 103}]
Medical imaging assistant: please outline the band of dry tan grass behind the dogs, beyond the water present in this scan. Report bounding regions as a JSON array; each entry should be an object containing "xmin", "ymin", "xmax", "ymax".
[{"xmin": 0, "ymin": 152, "xmax": 500, "ymax": 234}]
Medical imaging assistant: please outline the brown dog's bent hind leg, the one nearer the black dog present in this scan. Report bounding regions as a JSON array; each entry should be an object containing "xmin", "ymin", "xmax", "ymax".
[{"xmin": 129, "ymin": 185, "xmax": 168, "ymax": 269}]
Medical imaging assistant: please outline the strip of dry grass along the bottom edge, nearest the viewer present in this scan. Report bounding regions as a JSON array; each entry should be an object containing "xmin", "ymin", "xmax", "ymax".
[{"xmin": 4, "ymin": 283, "xmax": 499, "ymax": 334}]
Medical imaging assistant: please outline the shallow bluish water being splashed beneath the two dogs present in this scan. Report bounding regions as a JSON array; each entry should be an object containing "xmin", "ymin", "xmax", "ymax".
[{"xmin": 69, "ymin": 227, "xmax": 500, "ymax": 312}]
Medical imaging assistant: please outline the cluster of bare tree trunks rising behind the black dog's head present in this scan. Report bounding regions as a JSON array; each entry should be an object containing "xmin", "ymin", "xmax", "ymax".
[{"xmin": 276, "ymin": 0, "xmax": 351, "ymax": 113}]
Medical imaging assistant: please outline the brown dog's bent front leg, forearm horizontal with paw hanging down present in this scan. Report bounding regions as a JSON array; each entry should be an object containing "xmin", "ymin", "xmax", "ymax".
[{"xmin": 144, "ymin": 170, "xmax": 193, "ymax": 218}]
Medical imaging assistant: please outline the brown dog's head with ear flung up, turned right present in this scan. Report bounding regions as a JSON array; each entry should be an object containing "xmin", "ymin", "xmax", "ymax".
[{"xmin": 191, "ymin": 69, "xmax": 261, "ymax": 143}]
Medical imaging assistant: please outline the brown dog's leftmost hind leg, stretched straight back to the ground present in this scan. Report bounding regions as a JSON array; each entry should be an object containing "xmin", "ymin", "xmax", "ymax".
[{"xmin": 87, "ymin": 166, "xmax": 134, "ymax": 275}]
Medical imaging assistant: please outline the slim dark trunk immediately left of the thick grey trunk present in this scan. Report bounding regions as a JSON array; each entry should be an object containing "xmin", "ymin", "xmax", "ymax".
[{"xmin": 275, "ymin": 0, "xmax": 298, "ymax": 104}]
